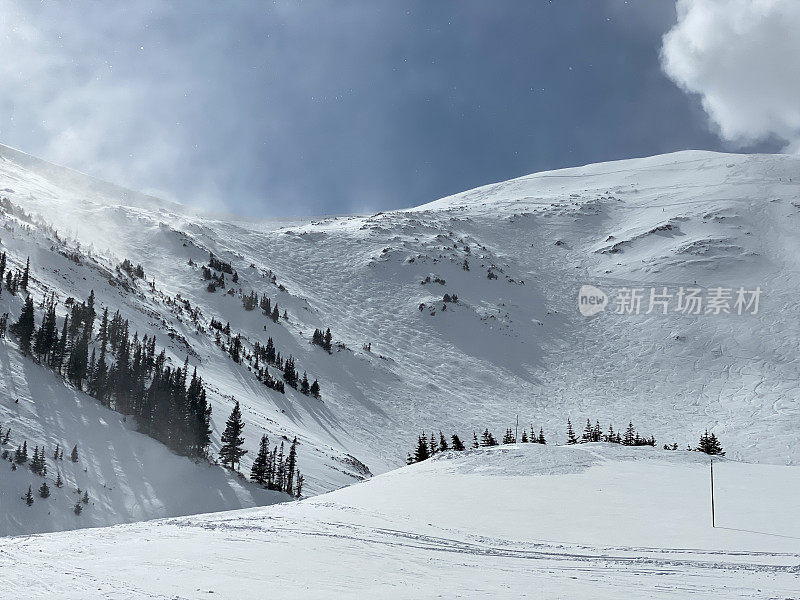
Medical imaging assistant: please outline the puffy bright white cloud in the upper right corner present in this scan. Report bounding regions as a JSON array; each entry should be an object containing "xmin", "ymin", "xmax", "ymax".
[{"xmin": 661, "ymin": 0, "xmax": 800, "ymax": 150}]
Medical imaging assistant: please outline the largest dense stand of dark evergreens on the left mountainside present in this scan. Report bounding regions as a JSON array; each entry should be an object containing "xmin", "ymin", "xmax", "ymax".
[{"xmin": 3, "ymin": 278, "xmax": 211, "ymax": 457}]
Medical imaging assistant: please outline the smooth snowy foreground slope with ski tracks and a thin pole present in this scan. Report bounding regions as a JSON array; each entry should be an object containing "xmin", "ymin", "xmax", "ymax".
[{"xmin": 0, "ymin": 444, "xmax": 800, "ymax": 600}]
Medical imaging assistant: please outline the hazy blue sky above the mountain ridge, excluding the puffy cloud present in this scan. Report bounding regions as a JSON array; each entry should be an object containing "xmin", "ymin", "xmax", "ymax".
[{"xmin": 0, "ymin": 0, "xmax": 780, "ymax": 216}]
